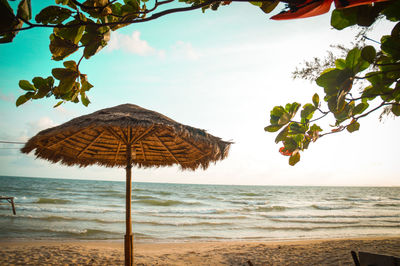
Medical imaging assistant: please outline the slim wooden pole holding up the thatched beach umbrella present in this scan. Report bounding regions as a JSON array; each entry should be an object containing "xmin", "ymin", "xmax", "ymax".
[{"xmin": 125, "ymin": 145, "xmax": 133, "ymax": 266}]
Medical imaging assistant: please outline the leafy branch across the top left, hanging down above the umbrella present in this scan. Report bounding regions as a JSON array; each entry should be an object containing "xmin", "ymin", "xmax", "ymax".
[{"xmin": 0, "ymin": 0, "xmax": 293, "ymax": 107}]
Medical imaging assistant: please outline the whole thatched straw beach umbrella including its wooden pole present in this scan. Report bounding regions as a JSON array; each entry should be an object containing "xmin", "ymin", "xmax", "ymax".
[{"xmin": 21, "ymin": 104, "xmax": 231, "ymax": 265}]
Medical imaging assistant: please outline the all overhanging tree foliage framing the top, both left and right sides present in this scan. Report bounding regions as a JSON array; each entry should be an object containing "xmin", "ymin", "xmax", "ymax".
[{"xmin": 0, "ymin": 0, "xmax": 400, "ymax": 165}]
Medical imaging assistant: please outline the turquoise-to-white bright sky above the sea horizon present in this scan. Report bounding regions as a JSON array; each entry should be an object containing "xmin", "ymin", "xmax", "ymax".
[{"xmin": 0, "ymin": 1, "xmax": 400, "ymax": 186}]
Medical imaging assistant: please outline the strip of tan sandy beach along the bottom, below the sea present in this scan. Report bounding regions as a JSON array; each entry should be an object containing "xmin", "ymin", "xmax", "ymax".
[{"xmin": 0, "ymin": 237, "xmax": 400, "ymax": 265}]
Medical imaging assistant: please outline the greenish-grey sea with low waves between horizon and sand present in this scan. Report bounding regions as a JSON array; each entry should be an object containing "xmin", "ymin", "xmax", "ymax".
[{"xmin": 0, "ymin": 176, "xmax": 400, "ymax": 242}]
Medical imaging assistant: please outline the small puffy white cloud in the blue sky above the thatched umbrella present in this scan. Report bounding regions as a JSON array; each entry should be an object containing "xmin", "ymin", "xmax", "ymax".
[{"xmin": 107, "ymin": 31, "xmax": 165, "ymax": 57}]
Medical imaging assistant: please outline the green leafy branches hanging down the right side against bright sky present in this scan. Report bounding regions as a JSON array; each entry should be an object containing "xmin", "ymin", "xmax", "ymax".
[{"xmin": 265, "ymin": 1, "xmax": 400, "ymax": 165}]
